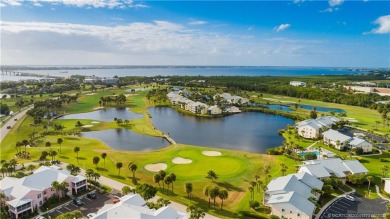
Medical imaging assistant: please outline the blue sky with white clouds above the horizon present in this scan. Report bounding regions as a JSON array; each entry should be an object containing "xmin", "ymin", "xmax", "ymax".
[{"xmin": 0, "ymin": 0, "xmax": 390, "ymax": 68}]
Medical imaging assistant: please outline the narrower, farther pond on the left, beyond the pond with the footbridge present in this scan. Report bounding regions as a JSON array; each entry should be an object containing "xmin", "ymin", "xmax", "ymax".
[{"xmin": 61, "ymin": 108, "xmax": 143, "ymax": 122}]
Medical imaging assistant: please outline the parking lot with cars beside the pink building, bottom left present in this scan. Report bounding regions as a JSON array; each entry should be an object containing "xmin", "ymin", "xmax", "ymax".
[{"xmin": 45, "ymin": 190, "xmax": 120, "ymax": 218}]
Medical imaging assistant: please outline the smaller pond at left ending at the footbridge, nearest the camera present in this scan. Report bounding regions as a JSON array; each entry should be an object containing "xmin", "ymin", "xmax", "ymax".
[{"xmin": 80, "ymin": 128, "xmax": 169, "ymax": 151}]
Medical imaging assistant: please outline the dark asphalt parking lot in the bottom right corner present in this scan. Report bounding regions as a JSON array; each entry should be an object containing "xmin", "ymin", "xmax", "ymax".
[{"xmin": 320, "ymin": 194, "xmax": 388, "ymax": 219}]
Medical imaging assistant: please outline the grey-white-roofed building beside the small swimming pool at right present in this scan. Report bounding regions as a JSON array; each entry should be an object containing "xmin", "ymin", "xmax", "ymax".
[{"xmin": 298, "ymin": 158, "xmax": 368, "ymax": 183}]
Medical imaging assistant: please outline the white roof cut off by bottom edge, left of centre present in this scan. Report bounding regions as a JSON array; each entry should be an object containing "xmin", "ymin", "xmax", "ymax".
[{"xmin": 92, "ymin": 194, "xmax": 189, "ymax": 219}]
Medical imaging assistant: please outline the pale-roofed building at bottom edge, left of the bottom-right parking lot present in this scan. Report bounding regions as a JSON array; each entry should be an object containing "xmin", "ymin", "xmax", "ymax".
[{"xmin": 264, "ymin": 172, "xmax": 324, "ymax": 219}]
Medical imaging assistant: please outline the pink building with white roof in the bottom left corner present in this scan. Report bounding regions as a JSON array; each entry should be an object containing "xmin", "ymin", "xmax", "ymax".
[{"xmin": 0, "ymin": 166, "xmax": 87, "ymax": 218}]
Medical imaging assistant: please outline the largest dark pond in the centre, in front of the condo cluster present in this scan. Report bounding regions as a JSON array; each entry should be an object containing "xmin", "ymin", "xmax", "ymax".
[{"xmin": 149, "ymin": 107, "xmax": 294, "ymax": 153}]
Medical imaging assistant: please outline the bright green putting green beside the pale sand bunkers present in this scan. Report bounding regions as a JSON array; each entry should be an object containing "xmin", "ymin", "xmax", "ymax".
[{"xmin": 169, "ymin": 157, "xmax": 247, "ymax": 181}]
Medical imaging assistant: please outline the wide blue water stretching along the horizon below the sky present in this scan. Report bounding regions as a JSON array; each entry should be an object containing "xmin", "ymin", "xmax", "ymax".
[{"xmin": 0, "ymin": 66, "xmax": 363, "ymax": 81}]
